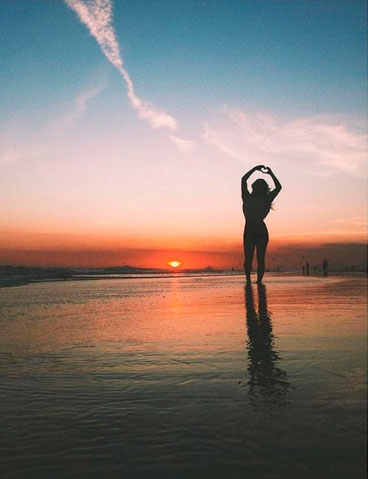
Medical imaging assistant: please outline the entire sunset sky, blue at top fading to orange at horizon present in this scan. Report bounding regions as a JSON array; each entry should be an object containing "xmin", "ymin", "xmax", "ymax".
[{"xmin": 0, "ymin": 0, "xmax": 367, "ymax": 268}]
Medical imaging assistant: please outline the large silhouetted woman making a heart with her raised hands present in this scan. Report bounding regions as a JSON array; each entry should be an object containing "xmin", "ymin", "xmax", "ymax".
[{"xmin": 242, "ymin": 165, "xmax": 282, "ymax": 283}]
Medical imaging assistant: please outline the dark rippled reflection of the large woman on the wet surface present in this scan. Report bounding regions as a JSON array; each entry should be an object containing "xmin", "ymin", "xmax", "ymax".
[{"xmin": 245, "ymin": 284, "xmax": 291, "ymax": 408}]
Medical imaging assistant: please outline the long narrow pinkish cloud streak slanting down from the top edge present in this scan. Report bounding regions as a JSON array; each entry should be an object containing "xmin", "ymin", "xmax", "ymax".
[{"xmin": 65, "ymin": 0, "xmax": 177, "ymax": 131}]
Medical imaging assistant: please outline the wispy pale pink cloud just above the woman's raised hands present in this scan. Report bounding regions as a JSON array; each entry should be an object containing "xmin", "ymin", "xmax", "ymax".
[{"xmin": 204, "ymin": 107, "xmax": 367, "ymax": 176}]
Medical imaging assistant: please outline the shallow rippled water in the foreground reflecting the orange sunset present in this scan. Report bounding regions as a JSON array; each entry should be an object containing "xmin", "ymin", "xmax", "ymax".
[{"xmin": 0, "ymin": 276, "xmax": 367, "ymax": 479}]
